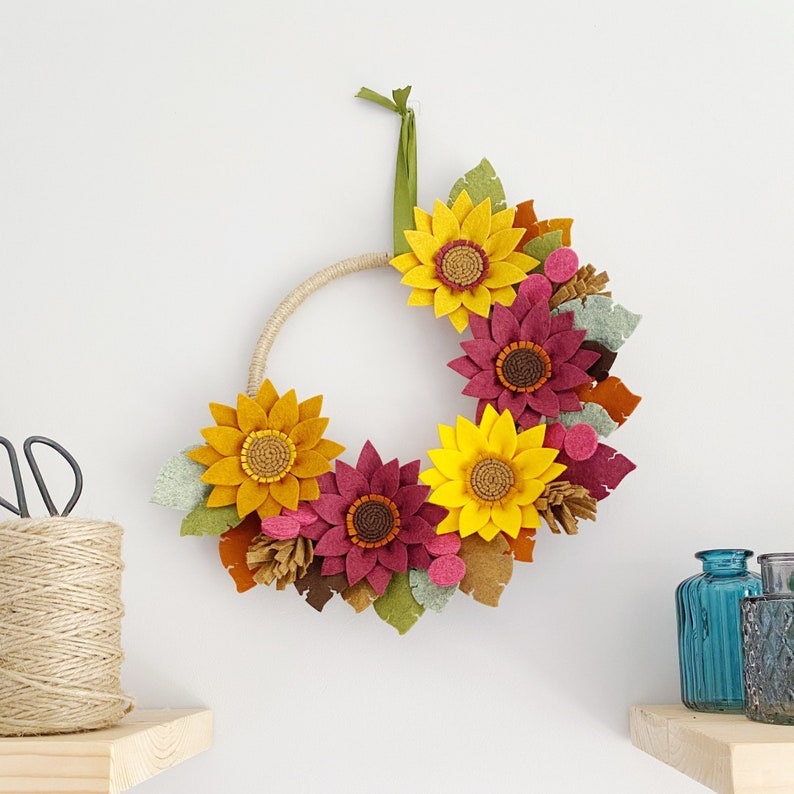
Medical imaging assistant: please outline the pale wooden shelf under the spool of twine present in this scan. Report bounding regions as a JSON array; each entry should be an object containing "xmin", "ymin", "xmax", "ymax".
[{"xmin": 0, "ymin": 709, "xmax": 212, "ymax": 794}]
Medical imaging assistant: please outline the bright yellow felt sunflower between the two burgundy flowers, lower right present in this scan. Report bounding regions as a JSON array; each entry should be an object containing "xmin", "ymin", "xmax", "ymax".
[{"xmin": 420, "ymin": 405, "xmax": 565, "ymax": 541}]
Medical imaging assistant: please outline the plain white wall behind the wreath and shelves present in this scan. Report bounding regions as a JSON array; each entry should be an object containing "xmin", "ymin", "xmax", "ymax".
[{"xmin": 0, "ymin": 0, "xmax": 794, "ymax": 794}]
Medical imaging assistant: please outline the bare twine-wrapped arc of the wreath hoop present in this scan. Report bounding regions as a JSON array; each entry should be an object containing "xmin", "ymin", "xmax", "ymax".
[{"xmin": 248, "ymin": 253, "xmax": 391, "ymax": 397}]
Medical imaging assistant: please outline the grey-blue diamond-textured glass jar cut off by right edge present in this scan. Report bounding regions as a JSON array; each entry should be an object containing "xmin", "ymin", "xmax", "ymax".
[{"xmin": 742, "ymin": 553, "xmax": 794, "ymax": 725}]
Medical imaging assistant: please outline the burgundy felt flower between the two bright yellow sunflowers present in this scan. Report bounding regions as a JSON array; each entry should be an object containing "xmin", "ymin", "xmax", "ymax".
[{"xmin": 449, "ymin": 290, "xmax": 599, "ymax": 429}]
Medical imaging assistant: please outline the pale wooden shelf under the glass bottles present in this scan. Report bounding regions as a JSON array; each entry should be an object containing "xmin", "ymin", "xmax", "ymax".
[{"xmin": 629, "ymin": 705, "xmax": 794, "ymax": 794}]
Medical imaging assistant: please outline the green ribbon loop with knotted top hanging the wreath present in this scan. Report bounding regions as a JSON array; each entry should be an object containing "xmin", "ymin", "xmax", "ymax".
[{"xmin": 356, "ymin": 86, "xmax": 417, "ymax": 256}]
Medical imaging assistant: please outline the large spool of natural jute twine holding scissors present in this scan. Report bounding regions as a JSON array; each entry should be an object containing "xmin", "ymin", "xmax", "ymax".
[{"xmin": 0, "ymin": 516, "xmax": 132, "ymax": 736}]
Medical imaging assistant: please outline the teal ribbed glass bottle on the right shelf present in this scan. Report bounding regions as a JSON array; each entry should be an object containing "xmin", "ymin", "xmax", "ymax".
[{"xmin": 675, "ymin": 549, "xmax": 761, "ymax": 712}]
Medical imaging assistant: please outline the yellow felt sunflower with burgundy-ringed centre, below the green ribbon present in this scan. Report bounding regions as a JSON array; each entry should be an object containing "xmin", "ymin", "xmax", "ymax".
[{"xmin": 391, "ymin": 190, "xmax": 539, "ymax": 333}]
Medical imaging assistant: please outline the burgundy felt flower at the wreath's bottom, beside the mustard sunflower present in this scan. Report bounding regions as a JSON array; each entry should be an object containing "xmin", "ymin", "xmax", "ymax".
[{"xmin": 300, "ymin": 441, "xmax": 447, "ymax": 595}]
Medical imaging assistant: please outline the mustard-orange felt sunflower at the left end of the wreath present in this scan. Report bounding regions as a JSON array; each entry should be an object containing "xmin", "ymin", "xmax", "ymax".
[{"xmin": 187, "ymin": 380, "xmax": 344, "ymax": 518}]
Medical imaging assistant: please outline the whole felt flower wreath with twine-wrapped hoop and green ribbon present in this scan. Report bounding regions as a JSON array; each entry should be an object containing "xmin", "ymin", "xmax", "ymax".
[{"xmin": 152, "ymin": 88, "xmax": 640, "ymax": 634}]
